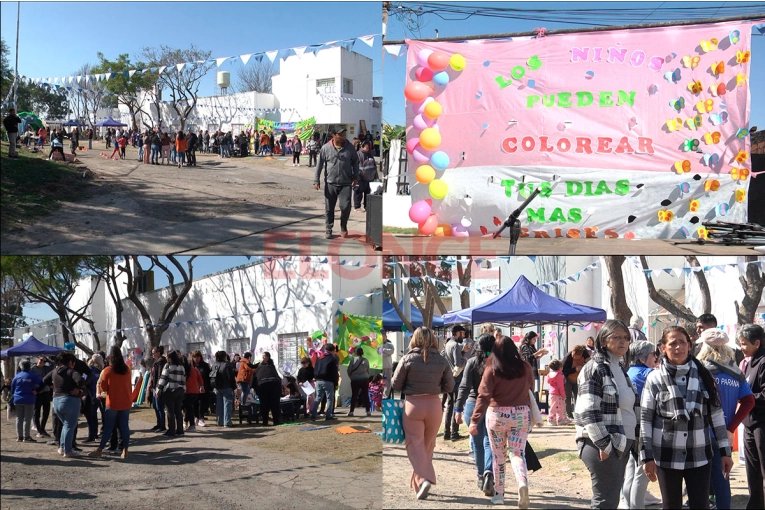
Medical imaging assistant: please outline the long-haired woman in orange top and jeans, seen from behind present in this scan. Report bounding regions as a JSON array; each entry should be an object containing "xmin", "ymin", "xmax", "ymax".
[{"xmin": 88, "ymin": 345, "xmax": 133, "ymax": 459}]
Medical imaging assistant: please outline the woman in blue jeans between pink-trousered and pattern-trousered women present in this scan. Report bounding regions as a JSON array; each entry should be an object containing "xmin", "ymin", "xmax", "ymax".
[{"xmin": 454, "ymin": 334, "xmax": 496, "ymax": 496}]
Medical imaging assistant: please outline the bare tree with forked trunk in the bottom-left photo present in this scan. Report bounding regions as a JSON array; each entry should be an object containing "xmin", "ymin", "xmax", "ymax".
[{"xmin": 119, "ymin": 255, "xmax": 196, "ymax": 349}]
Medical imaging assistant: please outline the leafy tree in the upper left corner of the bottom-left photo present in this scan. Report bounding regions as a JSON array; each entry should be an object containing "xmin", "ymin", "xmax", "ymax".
[{"xmin": 0, "ymin": 256, "xmax": 101, "ymax": 355}]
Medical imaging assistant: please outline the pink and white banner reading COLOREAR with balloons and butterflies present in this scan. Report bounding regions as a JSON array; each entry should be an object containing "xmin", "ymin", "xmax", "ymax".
[{"xmin": 405, "ymin": 22, "xmax": 753, "ymax": 238}]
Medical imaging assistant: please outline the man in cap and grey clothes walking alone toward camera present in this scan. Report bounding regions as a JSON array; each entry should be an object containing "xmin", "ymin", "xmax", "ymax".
[{"xmin": 313, "ymin": 126, "xmax": 359, "ymax": 239}]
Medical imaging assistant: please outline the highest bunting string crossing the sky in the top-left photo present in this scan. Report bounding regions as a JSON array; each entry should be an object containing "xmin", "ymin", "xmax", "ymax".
[{"xmin": 10, "ymin": 34, "xmax": 380, "ymax": 97}]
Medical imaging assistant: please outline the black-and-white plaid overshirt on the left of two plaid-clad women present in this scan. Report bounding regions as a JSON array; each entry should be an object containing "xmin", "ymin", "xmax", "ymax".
[{"xmin": 574, "ymin": 352, "xmax": 640, "ymax": 457}]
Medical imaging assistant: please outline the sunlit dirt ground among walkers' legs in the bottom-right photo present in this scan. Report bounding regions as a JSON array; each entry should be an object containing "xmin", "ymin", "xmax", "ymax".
[{"xmin": 383, "ymin": 416, "xmax": 748, "ymax": 508}]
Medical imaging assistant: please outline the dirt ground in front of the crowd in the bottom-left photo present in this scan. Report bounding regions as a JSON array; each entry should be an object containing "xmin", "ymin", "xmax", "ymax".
[{"xmin": 0, "ymin": 402, "xmax": 382, "ymax": 510}]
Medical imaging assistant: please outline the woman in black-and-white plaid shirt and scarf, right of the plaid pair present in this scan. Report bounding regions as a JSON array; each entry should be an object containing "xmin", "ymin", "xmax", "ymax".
[{"xmin": 640, "ymin": 326, "xmax": 733, "ymax": 508}]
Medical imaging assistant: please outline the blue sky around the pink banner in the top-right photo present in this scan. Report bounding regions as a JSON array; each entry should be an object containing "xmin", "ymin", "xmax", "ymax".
[{"xmin": 383, "ymin": 0, "xmax": 765, "ymax": 129}]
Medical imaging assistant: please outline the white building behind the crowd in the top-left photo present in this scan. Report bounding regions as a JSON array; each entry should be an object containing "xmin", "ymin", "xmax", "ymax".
[{"xmin": 115, "ymin": 47, "xmax": 382, "ymax": 138}]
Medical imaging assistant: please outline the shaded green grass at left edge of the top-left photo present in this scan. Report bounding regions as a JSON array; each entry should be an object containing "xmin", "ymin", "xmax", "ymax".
[{"xmin": 0, "ymin": 142, "xmax": 91, "ymax": 230}]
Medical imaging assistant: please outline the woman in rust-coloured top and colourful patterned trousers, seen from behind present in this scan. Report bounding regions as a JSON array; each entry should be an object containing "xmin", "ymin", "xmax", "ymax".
[{"xmin": 468, "ymin": 336, "xmax": 534, "ymax": 508}]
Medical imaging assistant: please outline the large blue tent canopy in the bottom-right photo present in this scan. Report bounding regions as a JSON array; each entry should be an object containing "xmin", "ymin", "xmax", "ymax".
[{"xmin": 444, "ymin": 275, "xmax": 606, "ymax": 324}]
